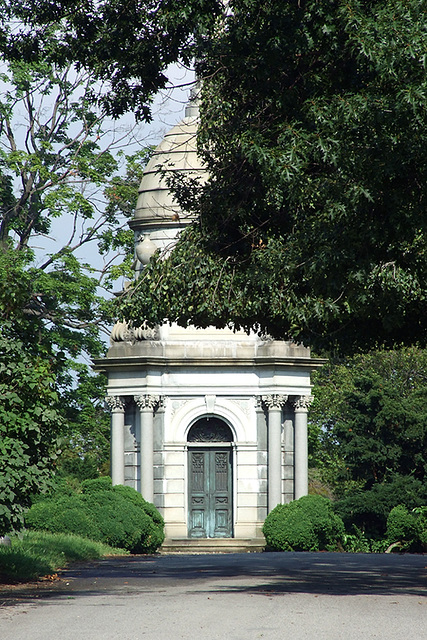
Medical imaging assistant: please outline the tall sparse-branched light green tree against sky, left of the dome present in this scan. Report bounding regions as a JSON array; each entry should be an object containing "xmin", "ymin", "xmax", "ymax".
[{"xmin": 0, "ymin": 62, "xmax": 150, "ymax": 530}]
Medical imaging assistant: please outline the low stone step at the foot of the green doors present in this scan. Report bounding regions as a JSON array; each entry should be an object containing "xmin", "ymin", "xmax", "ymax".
[{"xmin": 160, "ymin": 538, "xmax": 265, "ymax": 555}]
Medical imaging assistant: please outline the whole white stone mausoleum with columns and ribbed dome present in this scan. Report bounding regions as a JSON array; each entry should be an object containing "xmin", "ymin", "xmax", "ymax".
[{"xmin": 95, "ymin": 97, "xmax": 320, "ymax": 542}]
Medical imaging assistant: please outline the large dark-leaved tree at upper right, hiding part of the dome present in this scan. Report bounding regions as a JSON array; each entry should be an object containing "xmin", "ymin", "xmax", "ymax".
[{"xmin": 121, "ymin": 0, "xmax": 427, "ymax": 352}]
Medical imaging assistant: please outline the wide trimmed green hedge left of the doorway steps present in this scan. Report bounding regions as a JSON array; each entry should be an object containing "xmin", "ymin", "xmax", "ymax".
[{"xmin": 25, "ymin": 477, "xmax": 164, "ymax": 553}]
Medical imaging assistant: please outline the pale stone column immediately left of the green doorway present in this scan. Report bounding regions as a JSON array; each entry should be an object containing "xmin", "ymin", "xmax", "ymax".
[{"xmin": 135, "ymin": 395, "xmax": 159, "ymax": 502}]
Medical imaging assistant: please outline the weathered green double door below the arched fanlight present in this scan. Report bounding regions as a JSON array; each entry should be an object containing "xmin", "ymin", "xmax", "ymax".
[{"xmin": 188, "ymin": 448, "xmax": 233, "ymax": 538}]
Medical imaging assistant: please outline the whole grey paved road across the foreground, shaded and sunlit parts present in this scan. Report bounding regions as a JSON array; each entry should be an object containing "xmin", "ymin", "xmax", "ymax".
[{"xmin": 0, "ymin": 553, "xmax": 427, "ymax": 640}]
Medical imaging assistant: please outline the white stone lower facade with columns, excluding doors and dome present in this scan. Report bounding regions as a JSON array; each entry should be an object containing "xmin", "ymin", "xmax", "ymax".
[{"xmin": 97, "ymin": 327, "xmax": 315, "ymax": 538}]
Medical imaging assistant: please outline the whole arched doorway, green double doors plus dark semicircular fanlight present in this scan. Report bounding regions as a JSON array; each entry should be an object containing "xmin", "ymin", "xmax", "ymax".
[{"xmin": 187, "ymin": 418, "xmax": 233, "ymax": 538}]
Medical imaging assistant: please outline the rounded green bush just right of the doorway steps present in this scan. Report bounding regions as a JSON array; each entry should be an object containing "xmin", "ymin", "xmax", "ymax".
[{"xmin": 263, "ymin": 495, "xmax": 344, "ymax": 551}]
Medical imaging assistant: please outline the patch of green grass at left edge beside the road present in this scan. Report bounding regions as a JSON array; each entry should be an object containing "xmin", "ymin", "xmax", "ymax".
[{"xmin": 0, "ymin": 531, "xmax": 127, "ymax": 584}]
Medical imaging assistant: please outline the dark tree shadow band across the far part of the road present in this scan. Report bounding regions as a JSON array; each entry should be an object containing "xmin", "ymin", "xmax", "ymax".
[{"xmin": 0, "ymin": 553, "xmax": 427, "ymax": 605}]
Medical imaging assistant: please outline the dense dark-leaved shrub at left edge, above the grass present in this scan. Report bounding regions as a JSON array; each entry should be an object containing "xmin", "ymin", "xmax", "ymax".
[{"xmin": 0, "ymin": 322, "xmax": 62, "ymax": 534}]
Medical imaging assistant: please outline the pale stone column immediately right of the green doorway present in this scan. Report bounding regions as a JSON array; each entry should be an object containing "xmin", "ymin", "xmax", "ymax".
[{"xmin": 263, "ymin": 394, "xmax": 288, "ymax": 512}]
